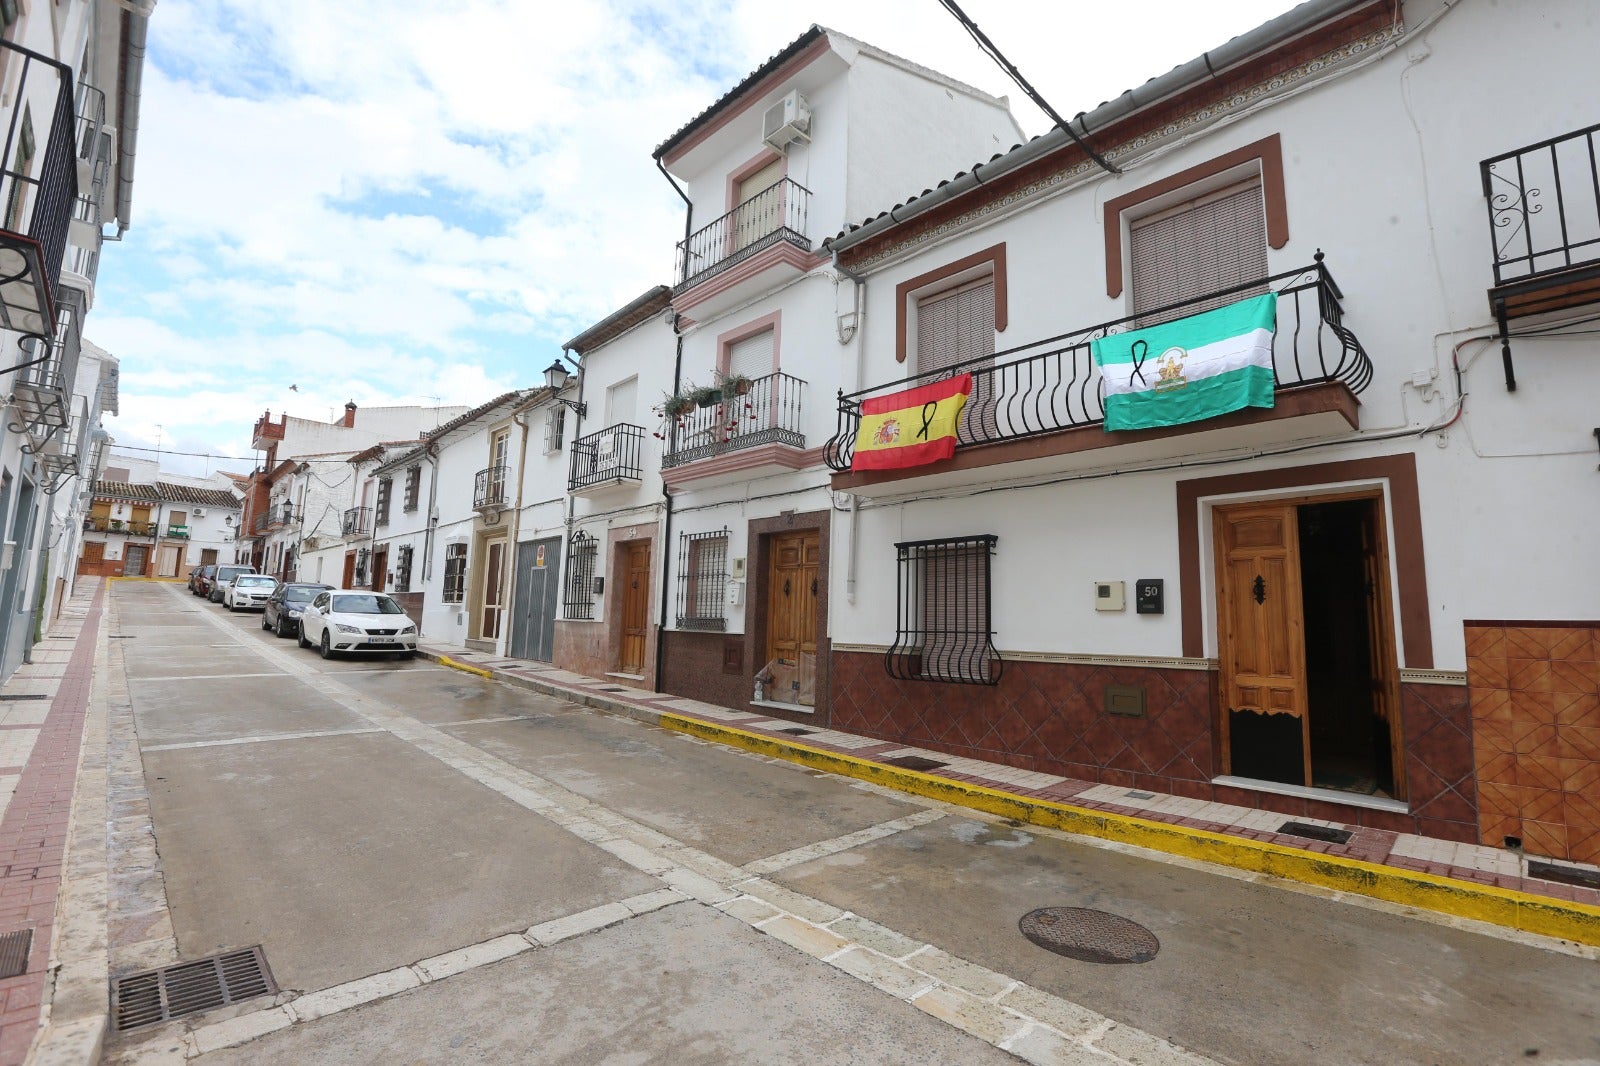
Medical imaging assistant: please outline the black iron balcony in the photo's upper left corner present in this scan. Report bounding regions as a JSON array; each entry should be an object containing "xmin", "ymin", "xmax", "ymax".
[{"xmin": 0, "ymin": 40, "xmax": 78, "ymax": 341}]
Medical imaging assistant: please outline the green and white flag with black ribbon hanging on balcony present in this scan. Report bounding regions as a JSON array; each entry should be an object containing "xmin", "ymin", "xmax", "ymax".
[{"xmin": 1090, "ymin": 293, "xmax": 1278, "ymax": 429}]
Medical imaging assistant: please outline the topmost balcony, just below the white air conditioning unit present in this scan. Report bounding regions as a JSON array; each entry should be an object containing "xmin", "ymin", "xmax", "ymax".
[{"xmin": 674, "ymin": 178, "xmax": 811, "ymax": 314}]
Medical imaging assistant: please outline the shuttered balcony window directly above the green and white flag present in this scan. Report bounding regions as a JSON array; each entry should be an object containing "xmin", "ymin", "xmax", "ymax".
[{"xmin": 1128, "ymin": 179, "xmax": 1267, "ymax": 325}]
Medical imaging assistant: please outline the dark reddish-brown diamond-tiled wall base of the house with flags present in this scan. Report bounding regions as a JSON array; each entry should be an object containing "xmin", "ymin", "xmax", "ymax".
[{"xmin": 832, "ymin": 651, "xmax": 1477, "ymax": 842}]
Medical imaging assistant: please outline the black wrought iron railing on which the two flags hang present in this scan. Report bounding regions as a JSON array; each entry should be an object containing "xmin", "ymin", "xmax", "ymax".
[{"xmin": 824, "ymin": 251, "xmax": 1373, "ymax": 471}]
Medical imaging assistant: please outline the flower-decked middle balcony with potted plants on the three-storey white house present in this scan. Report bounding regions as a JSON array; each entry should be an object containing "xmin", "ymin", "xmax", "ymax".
[{"xmin": 661, "ymin": 364, "xmax": 805, "ymax": 485}]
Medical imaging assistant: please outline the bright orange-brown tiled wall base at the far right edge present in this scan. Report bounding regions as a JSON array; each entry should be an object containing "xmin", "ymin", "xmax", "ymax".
[{"xmin": 1466, "ymin": 621, "xmax": 1600, "ymax": 863}]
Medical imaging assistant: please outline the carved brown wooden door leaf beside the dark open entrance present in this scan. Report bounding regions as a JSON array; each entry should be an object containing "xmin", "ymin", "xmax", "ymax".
[{"xmin": 1214, "ymin": 504, "xmax": 1310, "ymax": 784}]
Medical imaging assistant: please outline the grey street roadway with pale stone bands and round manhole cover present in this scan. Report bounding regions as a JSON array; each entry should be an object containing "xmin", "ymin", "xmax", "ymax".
[{"xmin": 107, "ymin": 583, "xmax": 1600, "ymax": 1064}]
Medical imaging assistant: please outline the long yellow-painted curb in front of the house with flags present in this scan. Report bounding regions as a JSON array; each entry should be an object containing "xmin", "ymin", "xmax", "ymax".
[{"xmin": 656, "ymin": 710, "xmax": 1600, "ymax": 944}]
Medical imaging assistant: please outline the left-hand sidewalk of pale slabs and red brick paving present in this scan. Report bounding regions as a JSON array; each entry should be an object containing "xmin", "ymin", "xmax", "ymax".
[{"xmin": 0, "ymin": 578, "xmax": 106, "ymax": 1064}]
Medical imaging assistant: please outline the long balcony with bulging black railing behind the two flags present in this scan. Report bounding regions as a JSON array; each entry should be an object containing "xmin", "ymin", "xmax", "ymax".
[{"xmin": 824, "ymin": 253, "xmax": 1373, "ymax": 495}]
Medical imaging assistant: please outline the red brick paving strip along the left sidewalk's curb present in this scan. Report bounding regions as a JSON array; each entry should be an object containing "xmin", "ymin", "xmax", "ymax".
[{"xmin": 0, "ymin": 581, "xmax": 106, "ymax": 1066}]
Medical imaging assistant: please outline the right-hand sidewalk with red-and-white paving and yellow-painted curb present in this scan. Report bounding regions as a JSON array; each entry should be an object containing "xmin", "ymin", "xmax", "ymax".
[{"xmin": 418, "ymin": 640, "xmax": 1600, "ymax": 946}]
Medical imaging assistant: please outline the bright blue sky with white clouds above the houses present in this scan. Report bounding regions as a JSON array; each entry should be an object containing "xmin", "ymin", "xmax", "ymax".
[{"xmin": 88, "ymin": 0, "xmax": 1291, "ymax": 472}]
